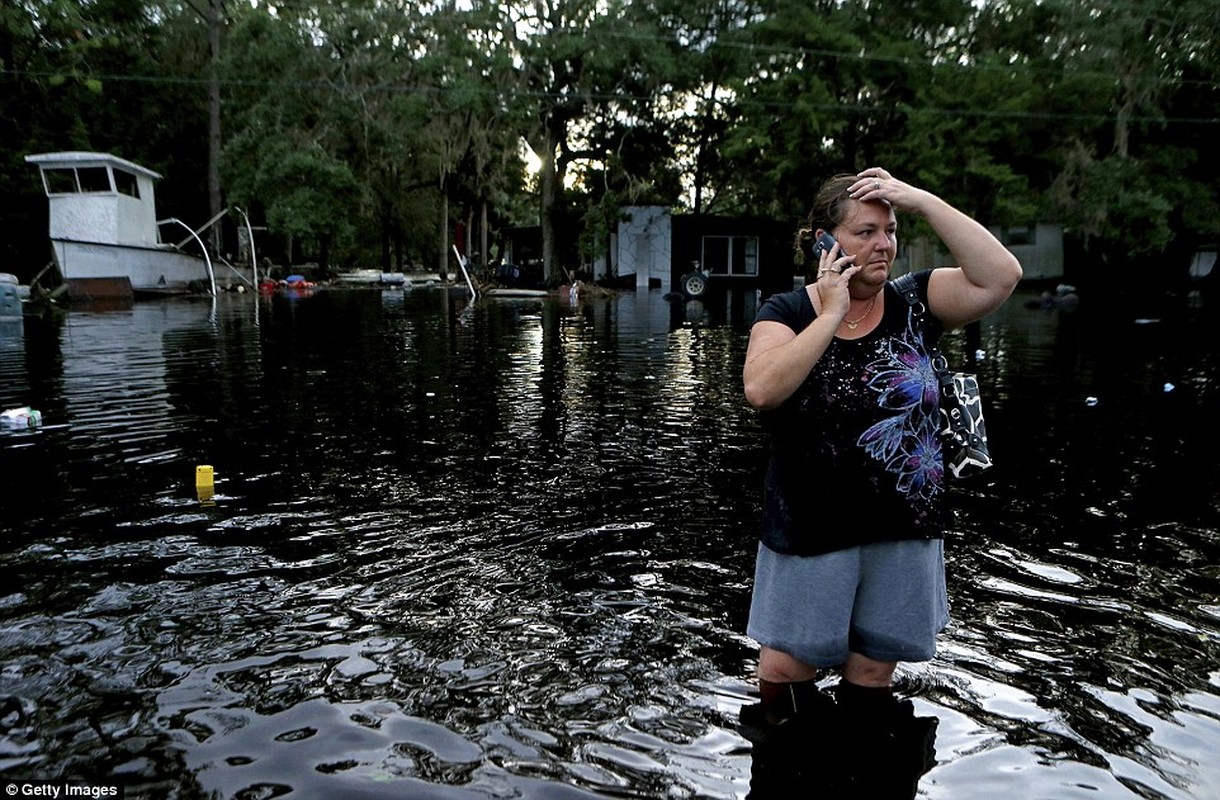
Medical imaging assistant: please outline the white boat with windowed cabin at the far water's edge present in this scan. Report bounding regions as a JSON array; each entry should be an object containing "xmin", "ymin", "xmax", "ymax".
[{"xmin": 26, "ymin": 151, "xmax": 256, "ymax": 299}]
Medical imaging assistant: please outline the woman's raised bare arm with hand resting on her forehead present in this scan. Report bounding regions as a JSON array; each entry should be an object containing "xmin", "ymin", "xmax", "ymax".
[{"xmin": 855, "ymin": 167, "xmax": 1021, "ymax": 328}]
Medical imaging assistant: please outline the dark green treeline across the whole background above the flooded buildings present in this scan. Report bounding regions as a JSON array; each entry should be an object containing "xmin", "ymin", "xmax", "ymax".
[{"xmin": 0, "ymin": 0, "xmax": 1220, "ymax": 283}]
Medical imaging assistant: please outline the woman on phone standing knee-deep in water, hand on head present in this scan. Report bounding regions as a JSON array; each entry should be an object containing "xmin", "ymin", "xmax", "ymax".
[{"xmin": 743, "ymin": 167, "xmax": 1021, "ymax": 768}]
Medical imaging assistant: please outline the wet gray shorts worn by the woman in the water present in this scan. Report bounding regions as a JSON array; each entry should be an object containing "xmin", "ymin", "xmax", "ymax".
[{"xmin": 747, "ymin": 539, "xmax": 949, "ymax": 667}]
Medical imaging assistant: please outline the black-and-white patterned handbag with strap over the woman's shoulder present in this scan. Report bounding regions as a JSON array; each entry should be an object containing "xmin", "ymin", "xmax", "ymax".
[{"xmin": 893, "ymin": 274, "xmax": 992, "ymax": 479}]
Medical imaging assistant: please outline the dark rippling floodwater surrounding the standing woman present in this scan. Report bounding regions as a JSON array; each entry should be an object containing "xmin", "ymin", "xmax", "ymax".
[{"xmin": 0, "ymin": 288, "xmax": 1220, "ymax": 800}]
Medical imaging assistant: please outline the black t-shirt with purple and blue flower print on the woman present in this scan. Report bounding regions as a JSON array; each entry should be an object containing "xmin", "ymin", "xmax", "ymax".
[{"xmin": 755, "ymin": 271, "xmax": 946, "ymax": 555}]
